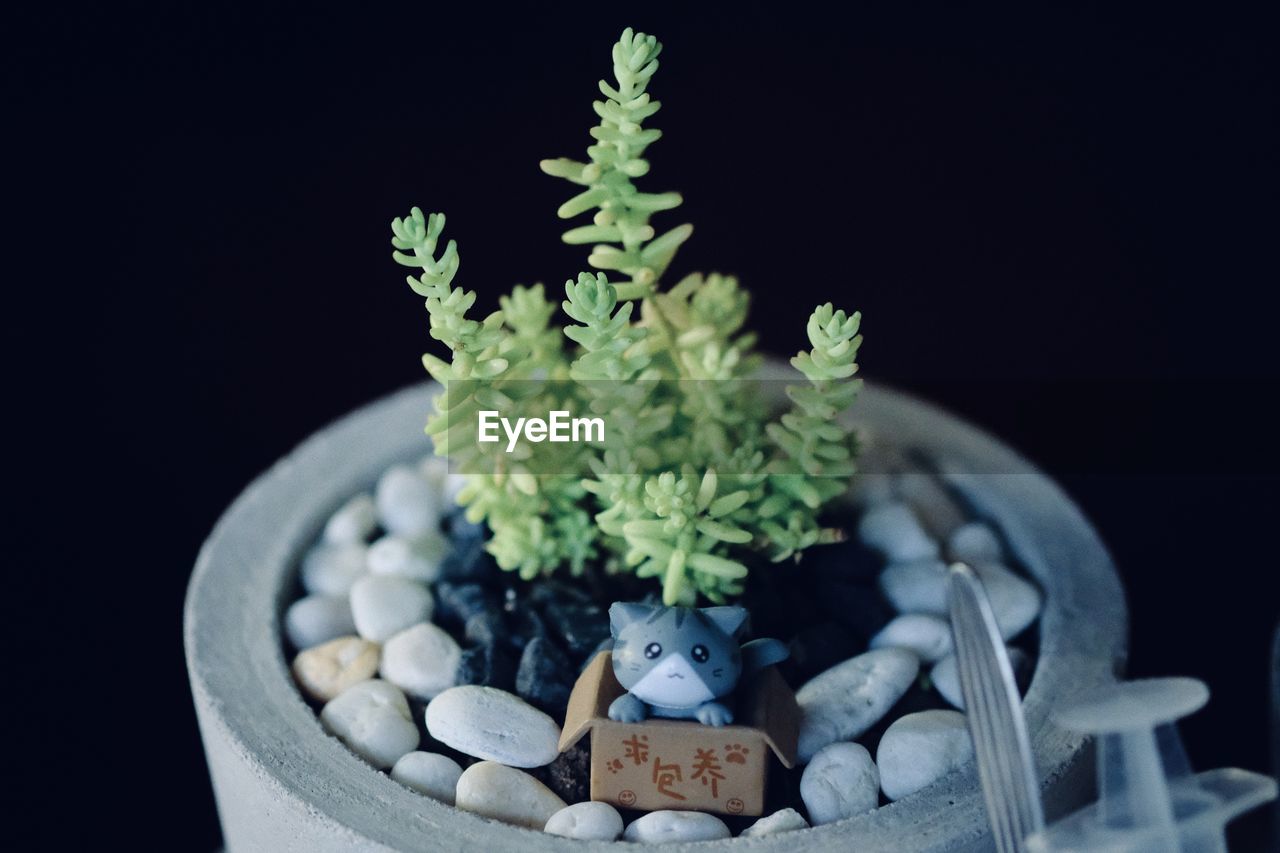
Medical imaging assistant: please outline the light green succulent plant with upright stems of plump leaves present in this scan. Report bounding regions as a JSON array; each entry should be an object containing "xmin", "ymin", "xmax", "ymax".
[{"xmin": 392, "ymin": 28, "xmax": 861, "ymax": 596}]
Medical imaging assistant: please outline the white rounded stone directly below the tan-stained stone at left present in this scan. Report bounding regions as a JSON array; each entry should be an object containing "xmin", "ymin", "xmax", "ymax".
[{"xmin": 320, "ymin": 679, "xmax": 419, "ymax": 770}]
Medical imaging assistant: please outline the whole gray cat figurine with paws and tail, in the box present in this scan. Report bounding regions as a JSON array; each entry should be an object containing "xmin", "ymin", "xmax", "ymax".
[{"xmin": 609, "ymin": 602, "xmax": 787, "ymax": 726}]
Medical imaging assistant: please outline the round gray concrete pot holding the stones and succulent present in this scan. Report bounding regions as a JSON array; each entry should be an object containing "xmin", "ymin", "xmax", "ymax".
[{"xmin": 186, "ymin": 371, "xmax": 1126, "ymax": 853}]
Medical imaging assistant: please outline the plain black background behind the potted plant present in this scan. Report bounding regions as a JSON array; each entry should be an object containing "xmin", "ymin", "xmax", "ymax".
[{"xmin": 6, "ymin": 3, "xmax": 1280, "ymax": 849}]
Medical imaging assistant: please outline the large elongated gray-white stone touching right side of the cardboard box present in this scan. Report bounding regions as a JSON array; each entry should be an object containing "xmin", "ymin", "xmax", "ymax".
[{"xmin": 796, "ymin": 648, "xmax": 920, "ymax": 763}]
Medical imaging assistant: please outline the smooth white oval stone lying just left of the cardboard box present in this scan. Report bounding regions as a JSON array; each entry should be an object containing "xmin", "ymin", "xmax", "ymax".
[{"xmin": 426, "ymin": 684, "xmax": 561, "ymax": 768}]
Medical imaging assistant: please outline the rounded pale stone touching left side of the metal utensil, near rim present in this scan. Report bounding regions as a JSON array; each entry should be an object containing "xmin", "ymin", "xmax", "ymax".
[{"xmin": 876, "ymin": 711, "xmax": 973, "ymax": 799}]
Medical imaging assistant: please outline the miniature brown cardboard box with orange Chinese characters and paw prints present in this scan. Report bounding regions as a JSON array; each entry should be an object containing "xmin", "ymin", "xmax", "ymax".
[{"xmin": 559, "ymin": 652, "xmax": 800, "ymax": 815}]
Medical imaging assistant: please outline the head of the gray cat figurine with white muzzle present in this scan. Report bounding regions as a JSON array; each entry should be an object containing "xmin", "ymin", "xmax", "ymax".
[{"xmin": 609, "ymin": 602, "xmax": 746, "ymax": 711}]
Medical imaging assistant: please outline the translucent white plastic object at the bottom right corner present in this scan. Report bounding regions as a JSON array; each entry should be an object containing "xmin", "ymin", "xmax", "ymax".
[{"xmin": 1027, "ymin": 678, "xmax": 1276, "ymax": 853}]
